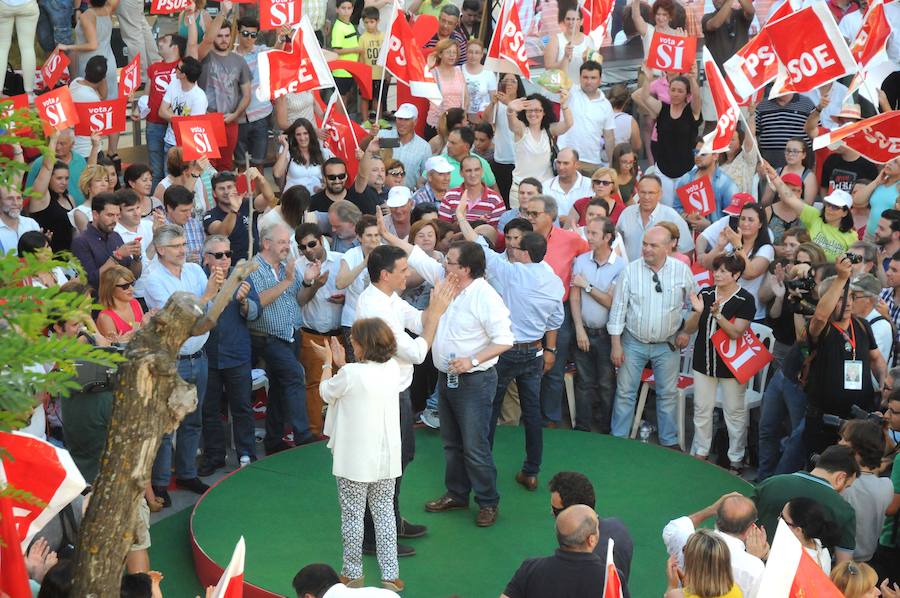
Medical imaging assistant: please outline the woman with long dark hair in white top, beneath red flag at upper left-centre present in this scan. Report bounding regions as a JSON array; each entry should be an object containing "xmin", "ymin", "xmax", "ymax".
[{"xmin": 272, "ymin": 118, "xmax": 332, "ymax": 194}]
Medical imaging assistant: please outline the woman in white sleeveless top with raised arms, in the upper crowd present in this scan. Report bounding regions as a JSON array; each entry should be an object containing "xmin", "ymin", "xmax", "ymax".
[{"xmin": 506, "ymin": 89, "xmax": 572, "ymax": 208}]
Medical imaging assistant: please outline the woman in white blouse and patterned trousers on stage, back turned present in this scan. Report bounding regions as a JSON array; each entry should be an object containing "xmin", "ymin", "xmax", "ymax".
[{"xmin": 312, "ymin": 318, "xmax": 404, "ymax": 592}]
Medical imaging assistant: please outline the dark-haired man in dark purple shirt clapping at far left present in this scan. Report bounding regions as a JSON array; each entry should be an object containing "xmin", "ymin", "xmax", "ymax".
[{"xmin": 72, "ymin": 193, "xmax": 141, "ymax": 290}]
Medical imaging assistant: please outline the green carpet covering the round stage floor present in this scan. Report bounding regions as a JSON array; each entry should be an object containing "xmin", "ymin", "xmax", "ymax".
[{"xmin": 151, "ymin": 427, "xmax": 750, "ymax": 598}]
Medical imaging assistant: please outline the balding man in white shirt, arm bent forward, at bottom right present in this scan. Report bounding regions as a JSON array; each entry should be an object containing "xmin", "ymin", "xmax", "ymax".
[{"xmin": 663, "ymin": 492, "xmax": 769, "ymax": 598}]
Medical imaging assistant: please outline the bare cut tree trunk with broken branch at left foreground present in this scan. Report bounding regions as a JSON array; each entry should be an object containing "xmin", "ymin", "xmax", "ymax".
[{"xmin": 70, "ymin": 262, "xmax": 257, "ymax": 598}]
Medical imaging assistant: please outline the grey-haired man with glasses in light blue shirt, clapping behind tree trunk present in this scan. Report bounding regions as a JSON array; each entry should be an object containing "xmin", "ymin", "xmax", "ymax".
[{"xmin": 144, "ymin": 224, "xmax": 226, "ymax": 506}]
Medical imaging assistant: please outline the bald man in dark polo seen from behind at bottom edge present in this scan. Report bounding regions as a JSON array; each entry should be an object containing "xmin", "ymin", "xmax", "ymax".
[{"xmin": 501, "ymin": 505, "xmax": 629, "ymax": 598}]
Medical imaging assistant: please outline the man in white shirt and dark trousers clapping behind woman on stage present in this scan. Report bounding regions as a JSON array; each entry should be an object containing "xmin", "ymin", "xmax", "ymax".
[{"xmin": 356, "ymin": 244, "xmax": 456, "ymax": 556}]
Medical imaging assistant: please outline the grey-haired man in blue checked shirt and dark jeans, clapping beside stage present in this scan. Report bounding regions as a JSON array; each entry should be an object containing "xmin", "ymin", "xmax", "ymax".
[{"xmin": 249, "ymin": 222, "xmax": 315, "ymax": 454}]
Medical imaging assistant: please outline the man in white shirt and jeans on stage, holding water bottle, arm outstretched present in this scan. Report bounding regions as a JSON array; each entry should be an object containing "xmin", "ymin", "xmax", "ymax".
[{"xmin": 379, "ymin": 213, "xmax": 514, "ymax": 527}]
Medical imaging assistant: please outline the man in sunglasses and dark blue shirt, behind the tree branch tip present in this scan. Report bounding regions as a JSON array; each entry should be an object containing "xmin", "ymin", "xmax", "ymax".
[{"xmin": 197, "ymin": 235, "xmax": 260, "ymax": 477}]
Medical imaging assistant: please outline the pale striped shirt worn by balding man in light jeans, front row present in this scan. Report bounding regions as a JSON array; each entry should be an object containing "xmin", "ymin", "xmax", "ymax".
[{"xmin": 606, "ymin": 257, "xmax": 699, "ymax": 343}]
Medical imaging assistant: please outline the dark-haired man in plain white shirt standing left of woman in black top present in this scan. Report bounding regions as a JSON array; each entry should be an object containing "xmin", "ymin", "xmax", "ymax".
[{"xmin": 556, "ymin": 60, "xmax": 616, "ymax": 173}]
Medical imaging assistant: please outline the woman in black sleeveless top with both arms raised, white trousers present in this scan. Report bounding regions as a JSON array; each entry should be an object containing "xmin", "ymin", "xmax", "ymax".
[{"xmin": 631, "ymin": 64, "xmax": 703, "ymax": 205}]
